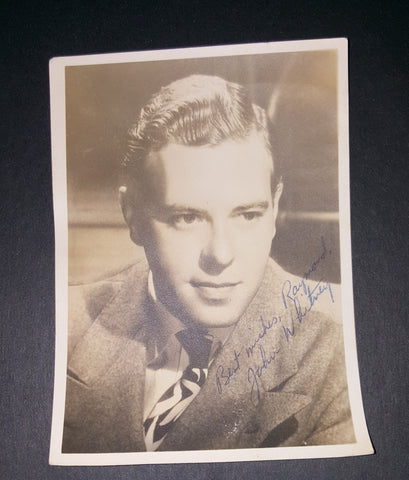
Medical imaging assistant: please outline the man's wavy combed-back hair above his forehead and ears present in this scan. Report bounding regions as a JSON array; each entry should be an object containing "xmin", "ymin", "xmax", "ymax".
[{"xmin": 122, "ymin": 75, "xmax": 279, "ymax": 197}]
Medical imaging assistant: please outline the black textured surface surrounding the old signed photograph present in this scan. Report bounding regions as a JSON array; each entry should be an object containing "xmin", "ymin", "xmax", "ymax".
[{"xmin": 0, "ymin": 0, "xmax": 409, "ymax": 480}]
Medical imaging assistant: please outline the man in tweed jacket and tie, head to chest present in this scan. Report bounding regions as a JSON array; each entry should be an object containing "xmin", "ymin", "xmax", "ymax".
[{"xmin": 63, "ymin": 69, "xmax": 354, "ymax": 452}]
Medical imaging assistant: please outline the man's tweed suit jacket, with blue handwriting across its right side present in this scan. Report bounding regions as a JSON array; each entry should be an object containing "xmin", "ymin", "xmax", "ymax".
[{"xmin": 62, "ymin": 260, "xmax": 355, "ymax": 453}]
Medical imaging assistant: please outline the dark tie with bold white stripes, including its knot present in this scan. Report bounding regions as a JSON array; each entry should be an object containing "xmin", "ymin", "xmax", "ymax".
[{"xmin": 144, "ymin": 329, "xmax": 212, "ymax": 450}]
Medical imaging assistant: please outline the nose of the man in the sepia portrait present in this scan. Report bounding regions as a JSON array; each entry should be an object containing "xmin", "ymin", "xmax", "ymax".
[{"xmin": 200, "ymin": 224, "xmax": 234, "ymax": 275}]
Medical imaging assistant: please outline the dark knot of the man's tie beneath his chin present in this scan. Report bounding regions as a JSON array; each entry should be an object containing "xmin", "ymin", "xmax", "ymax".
[{"xmin": 176, "ymin": 328, "xmax": 213, "ymax": 368}]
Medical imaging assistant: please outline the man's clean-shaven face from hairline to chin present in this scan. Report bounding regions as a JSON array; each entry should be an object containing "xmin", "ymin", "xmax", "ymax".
[{"xmin": 142, "ymin": 135, "xmax": 279, "ymax": 327}]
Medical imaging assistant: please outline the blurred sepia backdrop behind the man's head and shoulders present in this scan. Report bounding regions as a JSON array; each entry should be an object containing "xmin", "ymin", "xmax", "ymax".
[{"xmin": 67, "ymin": 50, "xmax": 340, "ymax": 283}]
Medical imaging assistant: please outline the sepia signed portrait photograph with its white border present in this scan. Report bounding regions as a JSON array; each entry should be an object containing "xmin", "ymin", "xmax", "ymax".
[{"xmin": 50, "ymin": 39, "xmax": 373, "ymax": 465}]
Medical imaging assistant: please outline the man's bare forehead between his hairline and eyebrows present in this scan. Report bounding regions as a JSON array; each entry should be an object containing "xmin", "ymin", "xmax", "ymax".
[{"xmin": 142, "ymin": 136, "xmax": 273, "ymax": 206}]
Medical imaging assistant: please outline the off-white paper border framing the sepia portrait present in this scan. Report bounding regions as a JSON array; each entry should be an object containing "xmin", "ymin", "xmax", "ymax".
[{"xmin": 49, "ymin": 38, "xmax": 373, "ymax": 465}]
